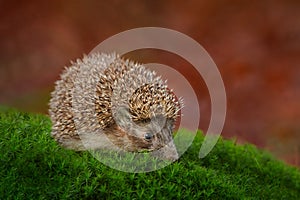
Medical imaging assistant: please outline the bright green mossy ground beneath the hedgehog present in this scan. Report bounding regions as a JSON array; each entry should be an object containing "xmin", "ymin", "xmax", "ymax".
[{"xmin": 0, "ymin": 107, "xmax": 300, "ymax": 199}]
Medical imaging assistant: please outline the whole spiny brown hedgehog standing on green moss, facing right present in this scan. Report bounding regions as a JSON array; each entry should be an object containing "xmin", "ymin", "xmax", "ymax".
[{"xmin": 49, "ymin": 53, "xmax": 183, "ymax": 161}]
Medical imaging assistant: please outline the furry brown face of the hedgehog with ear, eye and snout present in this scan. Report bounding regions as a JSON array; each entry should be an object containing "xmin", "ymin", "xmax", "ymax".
[{"xmin": 115, "ymin": 108, "xmax": 178, "ymax": 160}]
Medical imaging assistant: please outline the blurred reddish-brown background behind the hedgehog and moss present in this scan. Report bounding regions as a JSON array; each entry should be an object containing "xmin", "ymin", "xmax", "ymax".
[{"xmin": 0, "ymin": 0, "xmax": 300, "ymax": 165}]
